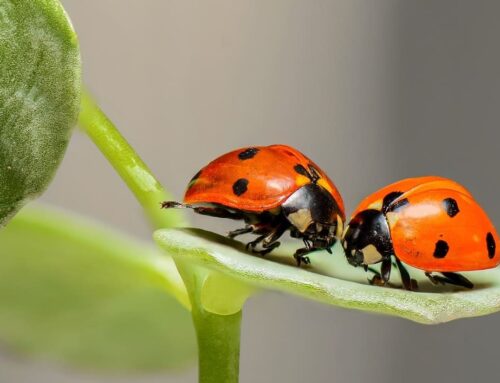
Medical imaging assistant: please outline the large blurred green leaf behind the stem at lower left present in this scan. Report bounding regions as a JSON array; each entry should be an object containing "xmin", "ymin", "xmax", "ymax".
[{"xmin": 0, "ymin": 207, "xmax": 196, "ymax": 371}]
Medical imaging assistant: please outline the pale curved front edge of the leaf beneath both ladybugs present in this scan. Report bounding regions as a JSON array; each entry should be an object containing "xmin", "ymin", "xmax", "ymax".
[{"xmin": 154, "ymin": 228, "xmax": 500, "ymax": 324}]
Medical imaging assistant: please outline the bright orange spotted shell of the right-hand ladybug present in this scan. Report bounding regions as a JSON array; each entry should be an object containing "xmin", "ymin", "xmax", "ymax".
[{"xmin": 355, "ymin": 177, "xmax": 500, "ymax": 272}]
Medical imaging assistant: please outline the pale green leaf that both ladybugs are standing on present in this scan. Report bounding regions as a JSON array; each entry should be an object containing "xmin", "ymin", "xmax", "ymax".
[{"xmin": 155, "ymin": 229, "xmax": 500, "ymax": 324}]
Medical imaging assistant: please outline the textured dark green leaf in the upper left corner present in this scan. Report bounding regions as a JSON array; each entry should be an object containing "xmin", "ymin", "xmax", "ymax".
[{"xmin": 0, "ymin": 0, "xmax": 80, "ymax": 226}]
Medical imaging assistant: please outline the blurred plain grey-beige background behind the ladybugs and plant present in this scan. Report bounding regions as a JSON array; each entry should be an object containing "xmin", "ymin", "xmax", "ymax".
[{"xmin": 0, "ymin": 0, "xmax": 500, "ymax": 383}]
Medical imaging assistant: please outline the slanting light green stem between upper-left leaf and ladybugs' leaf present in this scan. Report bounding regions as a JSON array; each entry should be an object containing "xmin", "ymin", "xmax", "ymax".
[{"xmin": 79, "ymin": 90, "xmax": 186, "ymax": 228}]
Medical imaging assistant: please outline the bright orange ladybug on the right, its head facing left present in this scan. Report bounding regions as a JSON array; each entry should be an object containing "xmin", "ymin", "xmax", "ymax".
[{"xmin": 342, "ymin": 176, "xmax": 500, "ymax": 290}]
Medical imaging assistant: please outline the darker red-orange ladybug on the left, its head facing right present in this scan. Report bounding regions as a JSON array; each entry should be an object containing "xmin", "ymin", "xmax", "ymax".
[{"xmin": 162, "ymin": 145, "xmax": 345, "ymax": 266}]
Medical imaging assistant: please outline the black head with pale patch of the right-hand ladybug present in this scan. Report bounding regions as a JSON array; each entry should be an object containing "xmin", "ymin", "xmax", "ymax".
[{"xmin": 342, "ymin": 209, "xmax": 394, "ymax": 266}]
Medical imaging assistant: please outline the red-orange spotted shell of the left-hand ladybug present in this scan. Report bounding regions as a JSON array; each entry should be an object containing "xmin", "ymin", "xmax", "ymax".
[{"xmin": 184, "ymin": 145, "xmax": 344, "ymax": 216}]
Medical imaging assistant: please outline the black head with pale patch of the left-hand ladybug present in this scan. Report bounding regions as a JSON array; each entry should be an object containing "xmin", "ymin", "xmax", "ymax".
[{"xmin": 282, "ymin": 183, "xmax": 344, "ymax": 249}]
